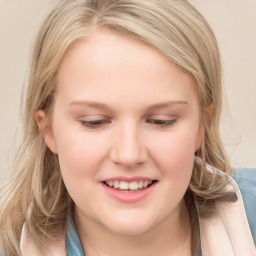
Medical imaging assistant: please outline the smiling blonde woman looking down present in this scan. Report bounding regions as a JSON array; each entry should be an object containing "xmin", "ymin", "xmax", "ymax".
[{"xmin": 0, "ymin": 0, "xmax": 255, "ymax": 256}]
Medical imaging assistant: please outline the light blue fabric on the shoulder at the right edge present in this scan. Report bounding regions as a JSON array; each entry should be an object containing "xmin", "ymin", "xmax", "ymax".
[{"xmin": 233, "ymin": 167, "xmax": 256, "ymax": 244}]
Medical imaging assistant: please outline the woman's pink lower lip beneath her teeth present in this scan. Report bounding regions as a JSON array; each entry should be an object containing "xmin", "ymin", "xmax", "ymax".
[{"xmin": 102, "ymin": 182, "xmax": 157, "ymax": 203}]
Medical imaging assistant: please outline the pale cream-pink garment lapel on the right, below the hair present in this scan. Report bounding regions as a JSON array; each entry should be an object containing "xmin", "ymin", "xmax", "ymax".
[{"xmin": 199, "ymin": 178, "xmax": 256, "ymax": 256}]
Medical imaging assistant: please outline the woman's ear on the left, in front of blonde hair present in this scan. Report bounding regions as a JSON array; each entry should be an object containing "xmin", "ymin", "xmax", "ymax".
[{"xmin": 34, "ymin": 110, "xmax": 57, "ymax": 154}]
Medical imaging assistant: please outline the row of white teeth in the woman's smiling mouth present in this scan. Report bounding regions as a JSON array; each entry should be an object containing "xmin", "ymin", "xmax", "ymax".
[{"xmin": 106, "ymin": 180, "xmax": 153, "ymax": 191}]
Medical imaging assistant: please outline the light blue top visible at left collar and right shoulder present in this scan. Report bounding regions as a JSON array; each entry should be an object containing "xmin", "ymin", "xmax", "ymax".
[{"xmin": 66, "ymin": 168, "xmax": 256, "ymax": 256}]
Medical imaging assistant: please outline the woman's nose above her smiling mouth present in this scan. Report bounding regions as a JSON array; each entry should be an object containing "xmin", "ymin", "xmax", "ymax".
[{"xmin": 110, "ymin": 124, "xmax": 148, "ymax": 168}]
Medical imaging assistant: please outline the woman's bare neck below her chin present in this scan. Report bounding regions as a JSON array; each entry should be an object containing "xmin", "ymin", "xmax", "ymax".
[{"xmin": 74, "ymin": 203, "xmax": 191, "ymax": 256}]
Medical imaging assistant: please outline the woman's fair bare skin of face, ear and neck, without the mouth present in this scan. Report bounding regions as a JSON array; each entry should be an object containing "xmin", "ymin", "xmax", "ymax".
[{"xmin": 35, "ymin": 31, "xmax": 202, "ymax": 256}]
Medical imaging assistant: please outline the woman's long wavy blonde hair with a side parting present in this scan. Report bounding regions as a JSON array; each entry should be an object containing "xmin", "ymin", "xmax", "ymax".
[{"xmin": 0, "ymin": 0, "xmax": 234, "ymax": 255}]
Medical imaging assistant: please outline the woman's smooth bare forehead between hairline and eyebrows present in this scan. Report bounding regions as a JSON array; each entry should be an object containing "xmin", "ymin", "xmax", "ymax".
[{"xmin": 58, "ymin": 31, "xmax": 199, "ymax": 109}]
